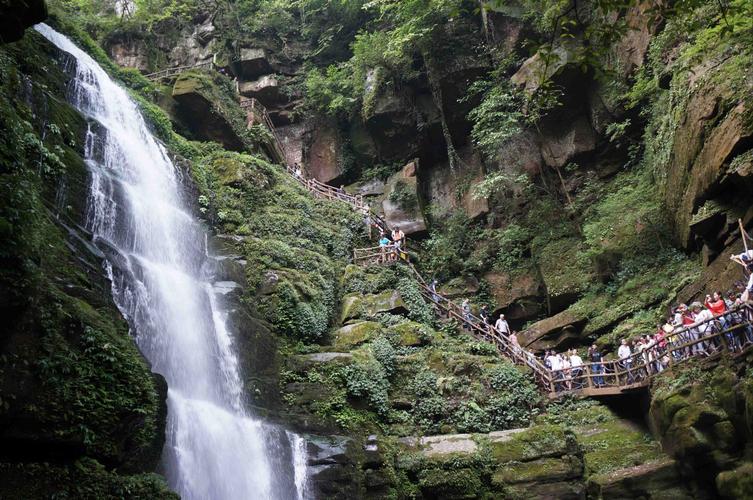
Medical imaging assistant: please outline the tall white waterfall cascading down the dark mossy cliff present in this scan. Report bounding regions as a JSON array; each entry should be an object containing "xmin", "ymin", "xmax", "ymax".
[{"xmin": 36, "ymin": 24, "xmax": 306, "ymax": 500}]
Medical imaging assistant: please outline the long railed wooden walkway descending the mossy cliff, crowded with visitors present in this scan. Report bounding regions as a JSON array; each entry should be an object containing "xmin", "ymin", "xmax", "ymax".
[{"xmin": 235, "ymin": 81, "xmax": 753, "ymax": 399}]
